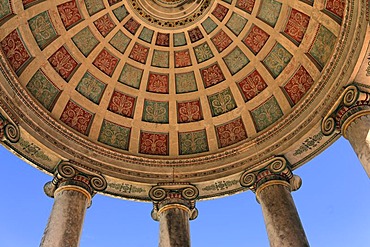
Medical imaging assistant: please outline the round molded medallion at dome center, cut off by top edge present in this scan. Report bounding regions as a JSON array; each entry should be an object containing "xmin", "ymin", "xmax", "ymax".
[{"xmin": 128, "ymin": 0, "xmax": 213, "ymax": 28}]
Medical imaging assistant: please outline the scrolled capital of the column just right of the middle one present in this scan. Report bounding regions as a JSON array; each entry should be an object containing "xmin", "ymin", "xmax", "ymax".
[{"xmin": 240, "ymin": 157, "xmax": 302, "ymax": 192}]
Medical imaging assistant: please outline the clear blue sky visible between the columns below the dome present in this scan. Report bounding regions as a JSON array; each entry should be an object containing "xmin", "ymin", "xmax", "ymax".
[{"xmin": 0, "ymin": 138, "xmax": 370, "ymax": 247}]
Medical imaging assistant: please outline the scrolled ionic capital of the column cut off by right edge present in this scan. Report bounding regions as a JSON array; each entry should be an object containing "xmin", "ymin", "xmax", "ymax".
[{"xmin": 321, "ymin": 85, "xmax": 370, "ymax": 138}]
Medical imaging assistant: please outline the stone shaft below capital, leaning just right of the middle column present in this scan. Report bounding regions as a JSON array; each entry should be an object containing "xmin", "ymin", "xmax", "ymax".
[{"xmin": 256, "ymin": 181, "xmax": 309, "ymax": 247}]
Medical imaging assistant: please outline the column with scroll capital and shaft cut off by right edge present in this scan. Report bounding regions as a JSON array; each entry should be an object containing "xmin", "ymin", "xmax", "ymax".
[{"xmin": 321, "ymin": 85, "xmax": 370, "ymax": 177}]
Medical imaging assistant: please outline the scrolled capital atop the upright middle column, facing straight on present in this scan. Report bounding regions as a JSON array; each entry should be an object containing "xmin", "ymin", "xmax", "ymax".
[{"xmin": 149, "ymin": 183, "xmax": 199, "ymax": 220}]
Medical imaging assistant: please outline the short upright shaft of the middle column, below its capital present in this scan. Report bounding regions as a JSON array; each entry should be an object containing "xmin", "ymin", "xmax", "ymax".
[{"xmin": 159, "ymin": 205, "xmax": 190, "ymax": 247}]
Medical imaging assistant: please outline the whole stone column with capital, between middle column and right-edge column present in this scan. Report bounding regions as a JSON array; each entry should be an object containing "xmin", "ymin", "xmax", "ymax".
[{"xmin": 240, "ymin": 157, "xmax": 309, "ymax": 247}]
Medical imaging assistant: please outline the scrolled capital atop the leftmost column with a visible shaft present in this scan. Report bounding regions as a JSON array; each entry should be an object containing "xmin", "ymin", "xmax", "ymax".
[{"xmin": 44, "ymin": 161, "xmax": 107, "ymax": 199}]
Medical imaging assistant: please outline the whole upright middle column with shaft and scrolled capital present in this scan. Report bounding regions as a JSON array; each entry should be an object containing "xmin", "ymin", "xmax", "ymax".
[{"xmin": 149, "ymin": 183, "xmax": 199, "ymax": 247}]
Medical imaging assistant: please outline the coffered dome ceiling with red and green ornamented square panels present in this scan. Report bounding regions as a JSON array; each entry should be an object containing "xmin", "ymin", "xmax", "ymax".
[{"xmin": 0, "ymin": 0, "xmax": 368, "ymax": 200}]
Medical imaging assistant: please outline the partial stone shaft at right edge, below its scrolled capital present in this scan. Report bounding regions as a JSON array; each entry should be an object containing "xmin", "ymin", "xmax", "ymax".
[{"xmin": 344, "ymin": 114, "xmax": 370, "ymax": 178}]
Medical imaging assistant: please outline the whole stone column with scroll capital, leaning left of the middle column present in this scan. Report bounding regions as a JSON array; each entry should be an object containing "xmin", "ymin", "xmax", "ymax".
[{"xmin": 40, "ymin": 162, "xmax": 107, "ymax": 247}]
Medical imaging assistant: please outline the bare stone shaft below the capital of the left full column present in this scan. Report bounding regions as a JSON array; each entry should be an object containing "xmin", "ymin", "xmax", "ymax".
[{"xmin": 40, "ymin": 186, "xmax": 91, "ymax": 247}]
